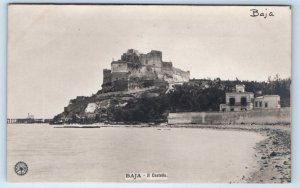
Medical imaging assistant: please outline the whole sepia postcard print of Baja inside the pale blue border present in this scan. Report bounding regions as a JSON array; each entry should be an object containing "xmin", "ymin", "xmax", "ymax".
[{"xmin": 6, "ymin": 4, "xmax": 292, "ymax": 184}]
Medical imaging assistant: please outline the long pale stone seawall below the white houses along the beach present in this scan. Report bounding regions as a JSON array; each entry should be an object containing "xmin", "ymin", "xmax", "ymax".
[{"xmin": 168, "ymin": 107, "xmax": 291, "ymax": 125}]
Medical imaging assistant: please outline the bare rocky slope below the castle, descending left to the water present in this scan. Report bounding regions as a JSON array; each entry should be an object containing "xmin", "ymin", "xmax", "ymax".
[{"xmin": 52, "ymin": 83, "xmax": 167, "ymax": 124}]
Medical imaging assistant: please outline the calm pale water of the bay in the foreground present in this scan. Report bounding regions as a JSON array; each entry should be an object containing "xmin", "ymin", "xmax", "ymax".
[{"xmin": 7, "ymin": 125, "xmax": 263, "ymax": 182}]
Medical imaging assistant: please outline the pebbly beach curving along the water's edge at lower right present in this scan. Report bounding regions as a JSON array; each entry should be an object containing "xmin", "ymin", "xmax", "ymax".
[{"xmin": 172, "ymin": 125, "xmax": 291, "ymax": 183}]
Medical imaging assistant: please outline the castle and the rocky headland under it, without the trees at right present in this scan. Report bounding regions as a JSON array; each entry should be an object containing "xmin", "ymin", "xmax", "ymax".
[{"xmin": 52, "ymin": 49, "xmax": 190, "ymax": 124}]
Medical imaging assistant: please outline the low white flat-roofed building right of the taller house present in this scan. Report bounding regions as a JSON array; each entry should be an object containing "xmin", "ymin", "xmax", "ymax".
[{"xmin": 254, "ymin": 95, "xmax": 280, "ymax": 109}]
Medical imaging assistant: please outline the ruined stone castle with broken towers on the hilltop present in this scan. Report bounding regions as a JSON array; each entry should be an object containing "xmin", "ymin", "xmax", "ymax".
[{"xmin": 102, "ymin": 49, "xmax": 190, "ymax": 93}]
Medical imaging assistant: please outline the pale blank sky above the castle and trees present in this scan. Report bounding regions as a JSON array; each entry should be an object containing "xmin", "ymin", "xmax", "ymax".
[{"xmin": 7, "ymin": 5, "xmax": 291, "ymax": 118}]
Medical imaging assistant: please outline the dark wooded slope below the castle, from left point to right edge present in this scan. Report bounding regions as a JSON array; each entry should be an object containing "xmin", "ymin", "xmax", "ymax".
[{"xmin": 53, "ymin": 76, "xmax": 291, "ymax": 123}]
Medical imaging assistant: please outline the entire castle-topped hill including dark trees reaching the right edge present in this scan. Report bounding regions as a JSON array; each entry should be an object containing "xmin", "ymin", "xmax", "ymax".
[{"xmin": 52, "ymin": 49, "xmax": 291, "ymax": 124}]
